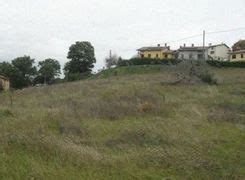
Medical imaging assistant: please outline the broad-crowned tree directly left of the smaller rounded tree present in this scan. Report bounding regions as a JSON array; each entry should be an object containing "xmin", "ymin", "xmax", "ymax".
[{"xmin": 12, "ymin": 56, "xmax": 37, "ymax": 87}]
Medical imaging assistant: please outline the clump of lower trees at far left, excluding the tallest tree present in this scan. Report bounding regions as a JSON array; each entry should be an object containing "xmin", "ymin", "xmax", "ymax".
[{"xmin": 0, "ymin": 56, "xmax": 60, "ymax": 89}]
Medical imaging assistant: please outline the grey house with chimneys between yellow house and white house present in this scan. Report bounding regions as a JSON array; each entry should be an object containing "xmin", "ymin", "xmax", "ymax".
[{"xmin": 178, "ymin": 44, "xmax": 208, "ymax": 60}]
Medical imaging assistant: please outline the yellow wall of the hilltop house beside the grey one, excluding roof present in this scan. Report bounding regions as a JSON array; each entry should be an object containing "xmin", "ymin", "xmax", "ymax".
[{"xmin": 139, "ymin": 51, "xmax": 174, "ymax": 59}]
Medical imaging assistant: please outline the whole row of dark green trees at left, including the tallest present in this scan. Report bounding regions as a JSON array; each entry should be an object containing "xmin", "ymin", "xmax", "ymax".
[{"xmin": 0, "ymin": 41, "xmax": 96, "ymax": 89}]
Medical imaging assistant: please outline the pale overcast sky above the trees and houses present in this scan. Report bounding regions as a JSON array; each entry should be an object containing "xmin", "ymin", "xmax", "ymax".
[{"xmin": 0, "ymin": 0, "xmax": 245, "ymax": 69}]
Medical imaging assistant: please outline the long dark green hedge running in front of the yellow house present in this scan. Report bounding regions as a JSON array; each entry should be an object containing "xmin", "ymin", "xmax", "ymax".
[{"xmin": 117, "ymin": 58, "xmax": 180, "ymax": 66}]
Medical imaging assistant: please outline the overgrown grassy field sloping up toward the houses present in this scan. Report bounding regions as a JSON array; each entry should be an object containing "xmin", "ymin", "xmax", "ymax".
[{"xmin": 0, "ymin": 62, "xmax": 245, "ymax": 180}]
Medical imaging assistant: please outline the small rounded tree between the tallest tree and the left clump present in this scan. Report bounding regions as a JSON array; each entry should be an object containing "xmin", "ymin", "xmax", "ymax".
[{"xmin": 38, "ymin": 59, "xmax": 60, "ymax": 84}]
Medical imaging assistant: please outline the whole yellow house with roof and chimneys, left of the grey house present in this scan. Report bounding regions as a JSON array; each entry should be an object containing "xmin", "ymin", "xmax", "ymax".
[{"xmin": 137, "ymin": 44, "xmax": 174, "ymax": 59}]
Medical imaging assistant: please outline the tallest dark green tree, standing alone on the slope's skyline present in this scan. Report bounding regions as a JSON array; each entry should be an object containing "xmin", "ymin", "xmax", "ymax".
[{"xmin": 64, "ymin": 41, "xmax": 96, "ymax": 80}]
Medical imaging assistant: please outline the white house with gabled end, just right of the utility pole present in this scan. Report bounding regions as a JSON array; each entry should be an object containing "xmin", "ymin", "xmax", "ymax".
[{"xmin": 208, "ymin": 43, "xmax": 230, "ymax": 61}]
